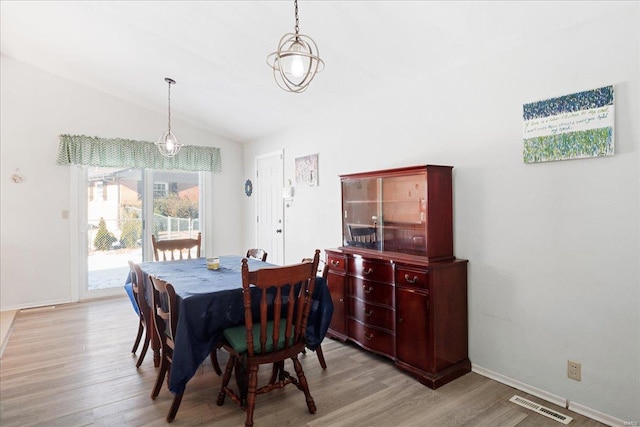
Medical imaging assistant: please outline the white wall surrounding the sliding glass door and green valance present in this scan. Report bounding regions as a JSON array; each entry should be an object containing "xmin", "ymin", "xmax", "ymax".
[{"xmin": 0, "ymin": 56, "xmax": 244, "ymax": 310}]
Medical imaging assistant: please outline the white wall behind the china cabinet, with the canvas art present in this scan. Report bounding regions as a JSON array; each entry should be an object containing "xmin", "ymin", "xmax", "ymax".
[{"xmin": 244, "ymin": 2, "xmax": 640, "ymax": 422}]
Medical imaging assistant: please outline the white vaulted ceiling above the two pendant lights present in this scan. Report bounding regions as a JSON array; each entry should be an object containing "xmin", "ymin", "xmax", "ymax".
[{"xmin": 0, "ymin": 0, "xmax": 624, "ymax": 142}]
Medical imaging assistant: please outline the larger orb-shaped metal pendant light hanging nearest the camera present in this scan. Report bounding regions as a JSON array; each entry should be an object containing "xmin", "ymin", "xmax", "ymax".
[{"xmin": 267, "ymin": 0, "xmax": 324, "ymax": 93}]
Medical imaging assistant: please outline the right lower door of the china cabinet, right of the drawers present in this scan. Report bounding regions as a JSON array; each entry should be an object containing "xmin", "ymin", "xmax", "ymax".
[{"xmin": 396, "ymin": 287, "xmax": 433, "ymax": 372}]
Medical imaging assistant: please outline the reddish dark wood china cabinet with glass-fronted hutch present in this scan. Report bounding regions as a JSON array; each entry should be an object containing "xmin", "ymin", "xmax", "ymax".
[{"xmin": 325, "ymin": 165, "xmax": 471, "ymax": 388}]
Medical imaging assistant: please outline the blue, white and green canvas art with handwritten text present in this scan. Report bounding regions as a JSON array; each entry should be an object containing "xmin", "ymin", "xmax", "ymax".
[{"xmin": 523, "ymin": 86, "xmax": 614, "ymax": 163}]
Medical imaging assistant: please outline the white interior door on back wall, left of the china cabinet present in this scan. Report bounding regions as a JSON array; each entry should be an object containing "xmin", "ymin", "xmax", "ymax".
[{"xmin": 255, "ymin": 151, "xmax": 284, "ymax": 265}]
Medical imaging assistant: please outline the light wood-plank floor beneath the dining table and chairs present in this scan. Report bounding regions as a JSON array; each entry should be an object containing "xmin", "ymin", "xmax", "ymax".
[{"xmin": 0, "ymin": 298, "xmax": 603, "ymax": 427}]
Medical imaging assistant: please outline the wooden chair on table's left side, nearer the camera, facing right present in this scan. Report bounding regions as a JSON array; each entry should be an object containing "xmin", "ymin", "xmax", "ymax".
[{"xmin": 150, "ymin": 276, "xmax": 220, "ymax": 422}]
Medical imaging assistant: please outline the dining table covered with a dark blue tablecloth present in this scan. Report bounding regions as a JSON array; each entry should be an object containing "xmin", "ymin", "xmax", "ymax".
[{"xmin": 124, "ymin": 255, "xmax": 333, "ymax": 394}]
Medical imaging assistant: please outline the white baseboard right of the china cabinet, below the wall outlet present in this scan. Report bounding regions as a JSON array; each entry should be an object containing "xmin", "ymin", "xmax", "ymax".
[{"xmin": 471, "ymin": 364, "xmax": 633, "ymax": 427}]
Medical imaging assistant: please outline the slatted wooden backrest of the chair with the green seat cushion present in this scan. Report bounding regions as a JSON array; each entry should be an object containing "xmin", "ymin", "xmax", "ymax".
[{"xmin": 242, "ymin": 249, "xmax": 320, "ymax": 357}]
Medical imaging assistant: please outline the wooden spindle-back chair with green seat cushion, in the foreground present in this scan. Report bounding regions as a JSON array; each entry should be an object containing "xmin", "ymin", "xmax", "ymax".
[{"xmin": 217, "ymin": 250, "xmax": 320, "ymax": 427}]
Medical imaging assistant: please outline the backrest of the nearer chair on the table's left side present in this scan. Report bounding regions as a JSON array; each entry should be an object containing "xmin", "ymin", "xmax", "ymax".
[{"xmin": 149, "ymin": 276, "xmax": 178, "ymax": 348}]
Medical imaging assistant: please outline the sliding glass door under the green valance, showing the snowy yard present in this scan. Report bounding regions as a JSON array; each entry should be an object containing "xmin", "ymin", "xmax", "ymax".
[{"xmin": 78, "ymin": 167, "xmax": 204, "ymax": 299}]
